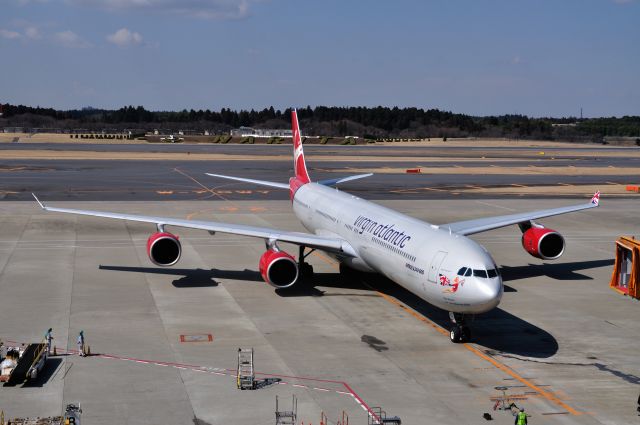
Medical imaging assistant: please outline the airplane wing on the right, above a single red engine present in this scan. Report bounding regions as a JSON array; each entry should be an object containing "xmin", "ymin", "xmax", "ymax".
[{"xmin": 440, "ymin": 192, "xmax": 600, "ymax": 235}]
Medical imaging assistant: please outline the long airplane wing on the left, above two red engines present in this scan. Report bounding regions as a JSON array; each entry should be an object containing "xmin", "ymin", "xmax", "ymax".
[{"xmin": 32, "ymin": 194, "xmax": 357, "ymax": 257}]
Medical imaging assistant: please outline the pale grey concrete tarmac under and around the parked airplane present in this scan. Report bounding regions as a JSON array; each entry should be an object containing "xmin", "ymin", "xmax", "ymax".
[{"xmin": 0, "ymin": 199, "xmax": 640, "ymax": 425}]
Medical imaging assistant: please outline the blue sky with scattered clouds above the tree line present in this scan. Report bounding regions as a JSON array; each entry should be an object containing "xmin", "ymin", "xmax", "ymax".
[{"xmin": 0, "ymin": 0, "xmax": 640, "ymax": 117}]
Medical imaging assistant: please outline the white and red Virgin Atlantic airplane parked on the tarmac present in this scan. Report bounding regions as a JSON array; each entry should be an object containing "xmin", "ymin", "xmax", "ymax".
[{"xmin": 33, "ymin": 110, "xmax": 600, "ymax": 343}]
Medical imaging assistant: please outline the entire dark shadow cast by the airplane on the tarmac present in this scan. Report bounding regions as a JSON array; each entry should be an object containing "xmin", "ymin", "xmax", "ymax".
[{"xmin": 100, "ymin": 259, "xmax": 614, "ymax": 358}]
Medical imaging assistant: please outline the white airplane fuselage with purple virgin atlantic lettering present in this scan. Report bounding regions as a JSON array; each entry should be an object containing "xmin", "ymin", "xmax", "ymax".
[{"xmin": 293, "ymin": 183, "xmax": 503, "ymax": 314}]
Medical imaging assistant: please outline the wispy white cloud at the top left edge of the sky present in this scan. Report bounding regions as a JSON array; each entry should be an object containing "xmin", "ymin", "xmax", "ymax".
[{"xmin": 66, "ymin": 0, "xmax": 256, "ymax": 19}]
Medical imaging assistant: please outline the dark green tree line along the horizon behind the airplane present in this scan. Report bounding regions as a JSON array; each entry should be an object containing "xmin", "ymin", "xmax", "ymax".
[{"xmin": 0, "ymin": 104, "xmax": 640, "ymax": 140}]
